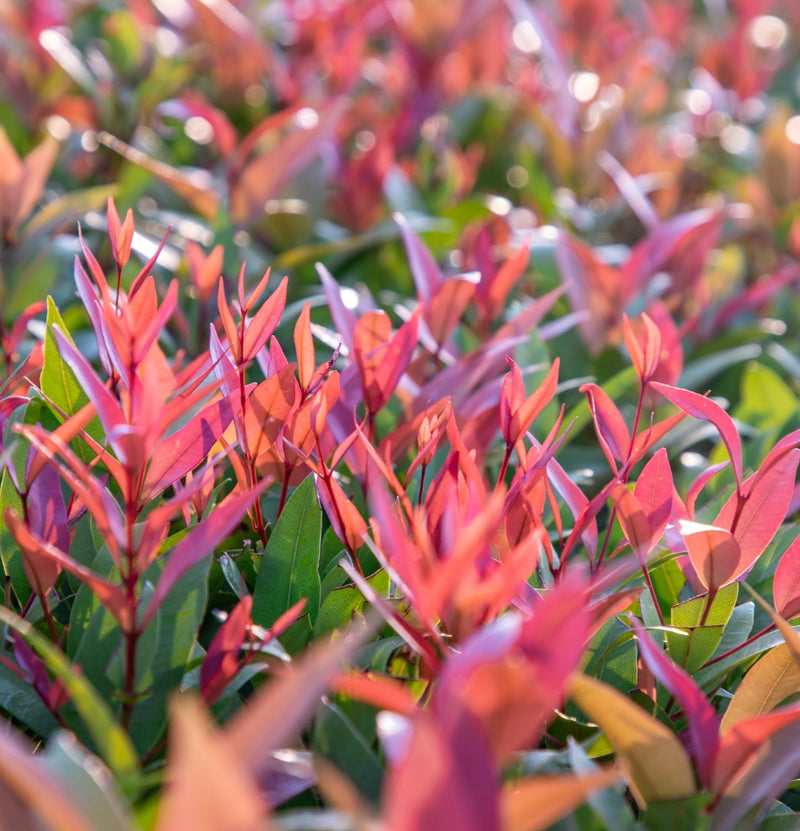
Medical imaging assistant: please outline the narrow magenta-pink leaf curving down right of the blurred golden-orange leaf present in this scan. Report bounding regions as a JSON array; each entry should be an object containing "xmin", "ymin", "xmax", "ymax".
[{"xmin": 630, "ymin": 617, "xmax": 719, "ymax": 788}]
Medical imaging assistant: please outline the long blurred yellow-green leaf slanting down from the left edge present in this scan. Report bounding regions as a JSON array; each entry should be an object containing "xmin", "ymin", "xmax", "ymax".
[{"xmin": 0, "ymin": 606, "xmax": 139, "ymax": 788}]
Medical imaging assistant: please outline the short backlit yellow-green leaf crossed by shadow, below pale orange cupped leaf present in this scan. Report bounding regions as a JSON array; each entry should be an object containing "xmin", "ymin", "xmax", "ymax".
[{"xmin": 667, "ymin": 583, "xmax": 739, "ymax": 673}]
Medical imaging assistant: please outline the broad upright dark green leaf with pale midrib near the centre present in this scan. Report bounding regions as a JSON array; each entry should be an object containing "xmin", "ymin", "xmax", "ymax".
[{"xmin": 253, "ymin": 476, "xmax": 322, "ymax": 653}]
